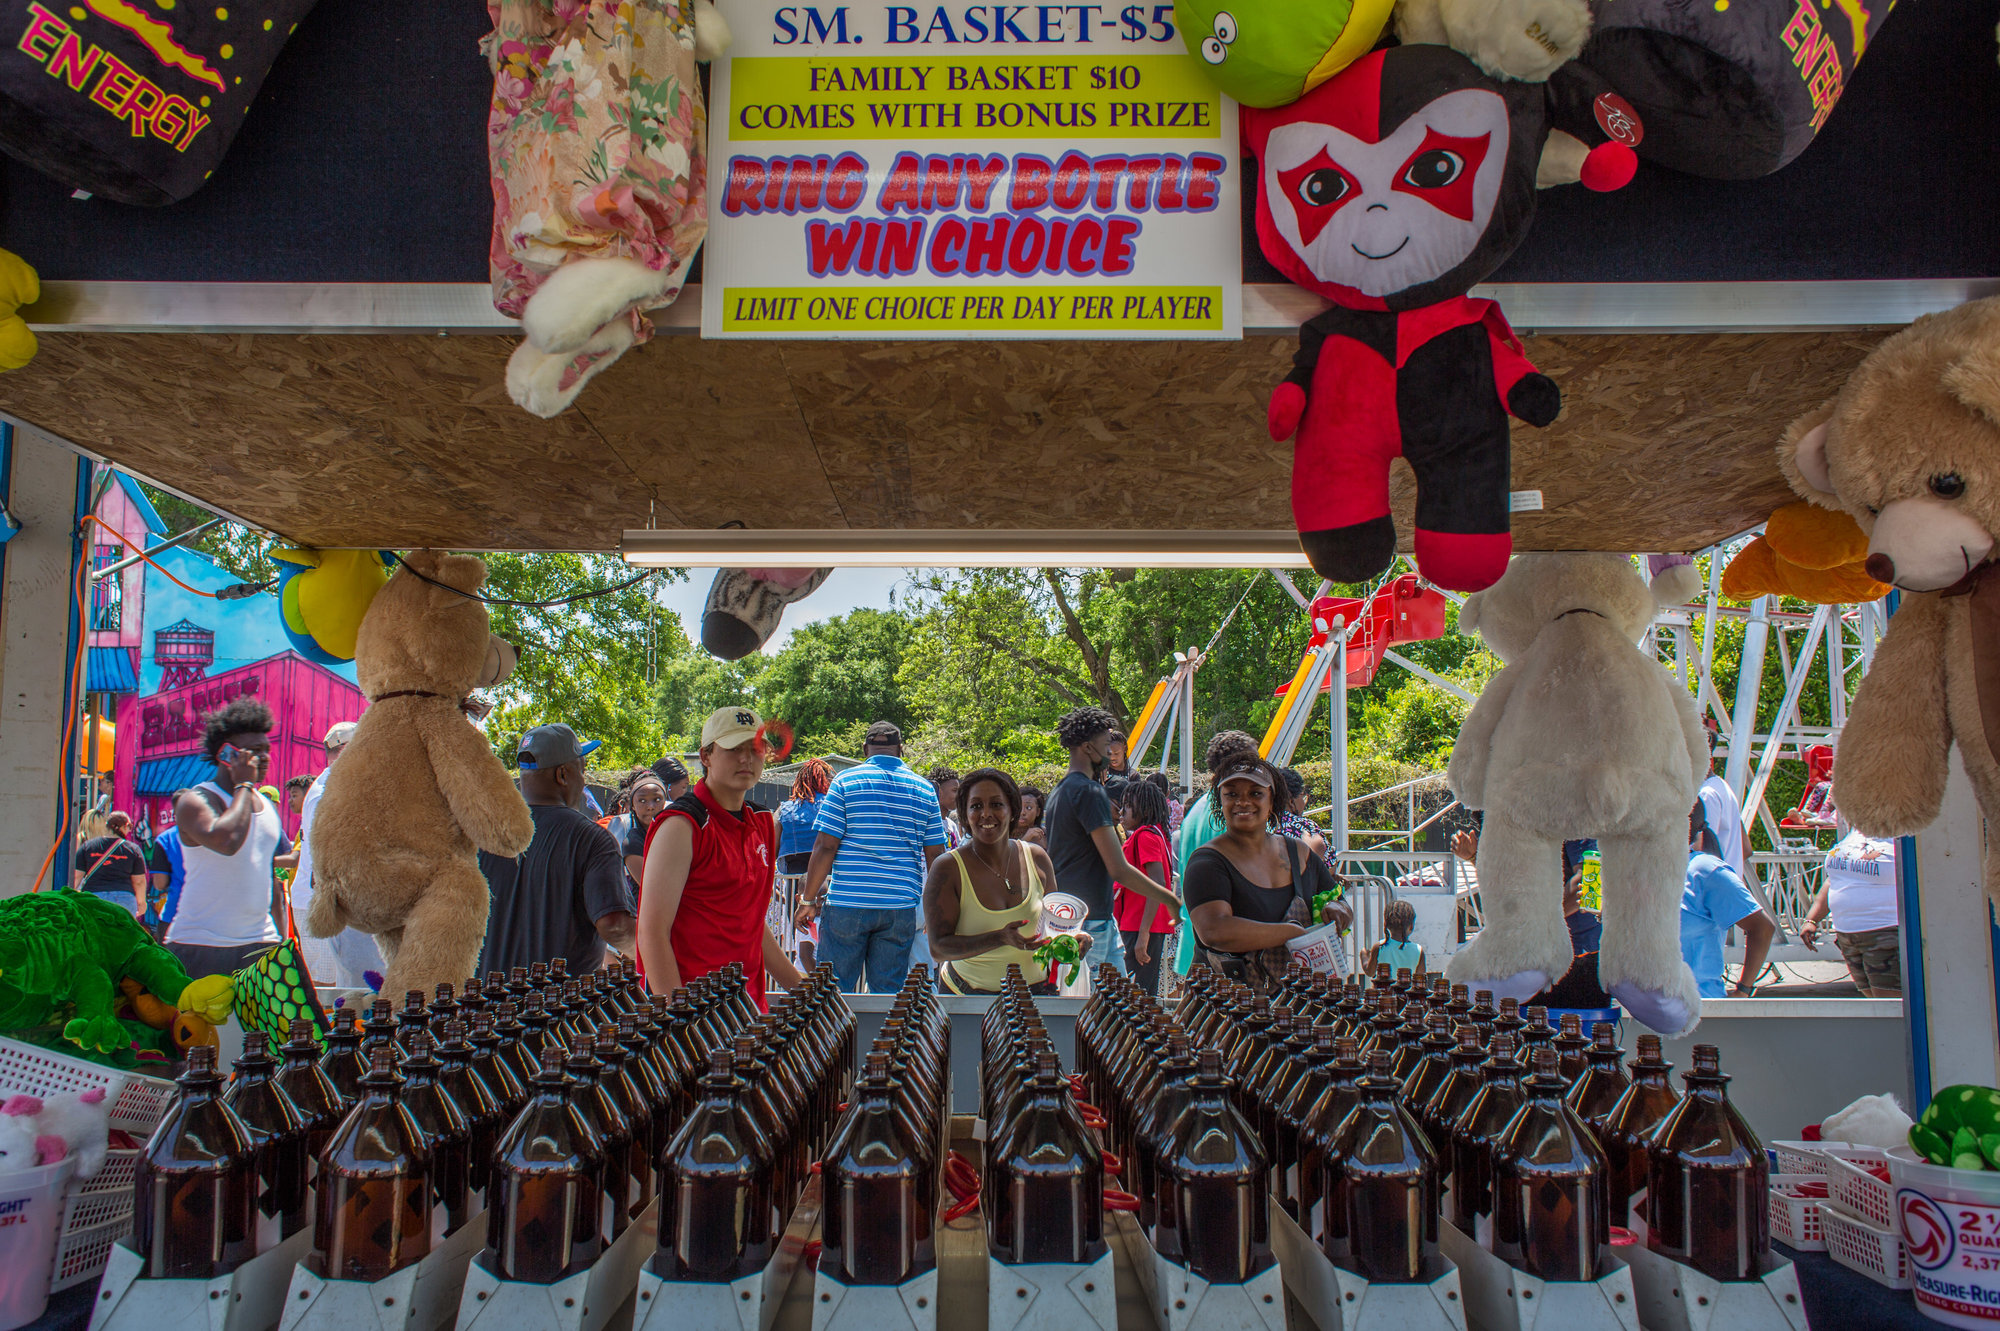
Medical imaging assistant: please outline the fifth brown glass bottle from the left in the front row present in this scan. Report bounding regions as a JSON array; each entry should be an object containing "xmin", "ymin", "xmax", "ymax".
[{"xmin": 820, "ymin": 1053, "xmax": 936, "ymax": 1285}]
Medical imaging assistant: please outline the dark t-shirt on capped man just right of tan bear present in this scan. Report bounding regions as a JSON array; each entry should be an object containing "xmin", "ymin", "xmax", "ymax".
[{"xmin": 480, "ymin": 803, "xmax": 634, "ymax": 975}]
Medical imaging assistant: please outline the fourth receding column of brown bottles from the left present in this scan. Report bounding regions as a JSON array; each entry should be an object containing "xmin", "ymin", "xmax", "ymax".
[{"xmin": 652, "ymin": 963, "xmax": 854, "ymax": 1281}]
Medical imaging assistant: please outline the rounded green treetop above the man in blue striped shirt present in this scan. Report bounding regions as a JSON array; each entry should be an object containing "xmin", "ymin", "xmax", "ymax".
[{"xmin": 756, "ymin": 608, "xmax": 910, "ymax": 753}]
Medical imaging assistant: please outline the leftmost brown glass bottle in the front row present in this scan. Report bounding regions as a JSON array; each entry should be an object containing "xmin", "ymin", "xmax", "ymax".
[{"xmin": 132, "ymin": 1045, "xmax": 258, "ymax": 1281}]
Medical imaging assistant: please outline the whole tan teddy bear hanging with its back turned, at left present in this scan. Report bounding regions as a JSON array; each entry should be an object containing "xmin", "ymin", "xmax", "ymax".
[{"xmin": 306, "ymin": 550, "xmax": 534, "ymax": 993}]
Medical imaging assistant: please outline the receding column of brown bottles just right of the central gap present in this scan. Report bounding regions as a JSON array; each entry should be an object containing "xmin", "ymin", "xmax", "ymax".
[{"xmin": 980, "ymin": 965, "xmax": 1106, "ymax": 1265}]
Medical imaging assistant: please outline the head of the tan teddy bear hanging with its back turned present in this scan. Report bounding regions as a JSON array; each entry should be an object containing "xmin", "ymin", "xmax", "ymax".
[{"xmin": 354, "ymin": 550, "xmax": 516, "ymax": 697}]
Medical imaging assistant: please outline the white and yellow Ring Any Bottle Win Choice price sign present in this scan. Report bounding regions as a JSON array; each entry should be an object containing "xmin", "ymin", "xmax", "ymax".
[{"xmin": 702, "ymin": 0, "xmax": 1242, "ymax": 338}]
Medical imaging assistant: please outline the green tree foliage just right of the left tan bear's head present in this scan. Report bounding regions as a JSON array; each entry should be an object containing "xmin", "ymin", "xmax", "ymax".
[{"xmin": 484, "ymin": 554, "xmax": 694, "ymax": 767}]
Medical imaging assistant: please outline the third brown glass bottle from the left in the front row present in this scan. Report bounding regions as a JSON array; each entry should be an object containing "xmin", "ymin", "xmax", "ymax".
[{"xmin": 484, "ymin": 1047, "xmax": 604, "ymax": 1285}]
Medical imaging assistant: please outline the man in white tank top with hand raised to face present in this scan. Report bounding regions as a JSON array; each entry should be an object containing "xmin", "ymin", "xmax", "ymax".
[{"xmin": 166, "ymin": 697, "xmax": 292, "ymax": 977}]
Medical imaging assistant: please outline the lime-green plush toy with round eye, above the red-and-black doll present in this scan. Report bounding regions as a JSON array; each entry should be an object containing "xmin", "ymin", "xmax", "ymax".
[{"xmin": 1174, "ymin": 0, "xmax": 1394, "ymax": 108}]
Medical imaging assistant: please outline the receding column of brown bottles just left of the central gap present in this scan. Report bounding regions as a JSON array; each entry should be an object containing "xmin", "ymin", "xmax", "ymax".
[{"xmin": 818, "ymin": 965, "xmax": 952, "ymax": 1285}]
